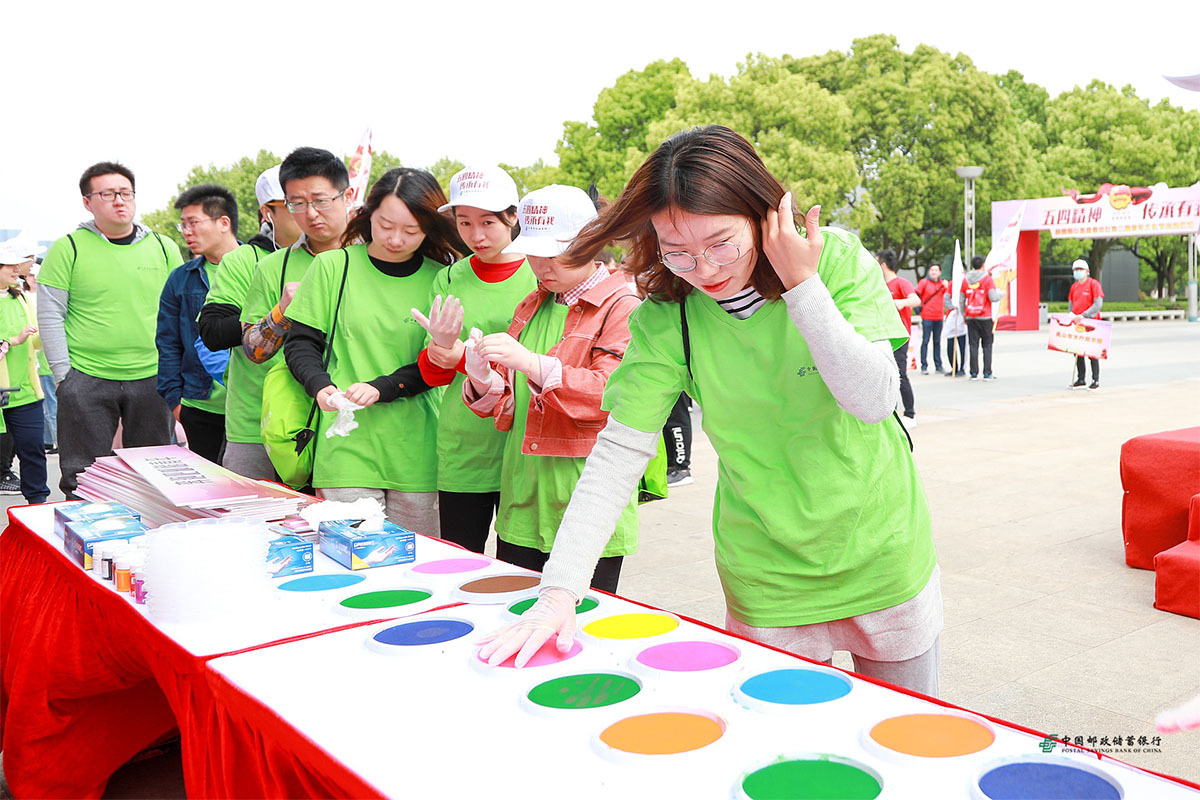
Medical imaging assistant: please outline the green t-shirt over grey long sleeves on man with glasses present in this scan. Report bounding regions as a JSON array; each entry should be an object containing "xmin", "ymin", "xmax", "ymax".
[{"xmin": 37, "ymin": 228, "xmax": 182, "ymax": 380}]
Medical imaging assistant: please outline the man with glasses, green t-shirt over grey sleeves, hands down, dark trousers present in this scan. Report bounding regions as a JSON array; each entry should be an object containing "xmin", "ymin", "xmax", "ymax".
[{"xmin": 37, "ymin": 162, "xmax": 182, "ymax": 499}]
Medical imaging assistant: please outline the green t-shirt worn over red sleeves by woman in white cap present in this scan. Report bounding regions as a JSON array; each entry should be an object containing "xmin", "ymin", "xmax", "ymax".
[{"xmin": 429, "ymin": 258, "xmax": 538, "ymax": 492}]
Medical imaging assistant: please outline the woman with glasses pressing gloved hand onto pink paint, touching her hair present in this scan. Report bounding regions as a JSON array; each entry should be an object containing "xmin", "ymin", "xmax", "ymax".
[{"xmin": 481, "ymin": 126, "xmax": 942, "ymax": 696}]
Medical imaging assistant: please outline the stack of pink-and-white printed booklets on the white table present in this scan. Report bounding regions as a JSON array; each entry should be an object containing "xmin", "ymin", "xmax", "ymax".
[{"xmin": 76, "ymin": 445, "xmax": 314, "ymax": 527}]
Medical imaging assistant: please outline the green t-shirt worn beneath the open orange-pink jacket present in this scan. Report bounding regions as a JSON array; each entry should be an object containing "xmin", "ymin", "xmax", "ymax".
[{"xmin": 496, "ymin": 295, "xmax": 643, "ymax": 558}]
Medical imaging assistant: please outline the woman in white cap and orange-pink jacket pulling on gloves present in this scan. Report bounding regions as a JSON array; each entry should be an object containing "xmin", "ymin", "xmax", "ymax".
[{"xmin": 451, "ymin": 185, "xmax": 638, "ymax": 591}]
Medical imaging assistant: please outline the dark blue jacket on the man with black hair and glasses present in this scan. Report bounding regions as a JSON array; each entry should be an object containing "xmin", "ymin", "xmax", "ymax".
[{"xmin": 155, "ymin": 255, "xmax": 228, "ymax": 408}]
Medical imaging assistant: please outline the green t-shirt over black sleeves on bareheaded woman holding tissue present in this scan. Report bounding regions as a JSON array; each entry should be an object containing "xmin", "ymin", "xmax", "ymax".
[{"xmin": 284, "ymin": 245, "xmax": 443, "ymax": 492}]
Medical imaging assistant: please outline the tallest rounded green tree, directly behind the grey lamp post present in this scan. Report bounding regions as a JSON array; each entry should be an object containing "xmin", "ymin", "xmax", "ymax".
[{"xmin": 785, "ymin": 35, "xmax": 1038, "ymax": 275}]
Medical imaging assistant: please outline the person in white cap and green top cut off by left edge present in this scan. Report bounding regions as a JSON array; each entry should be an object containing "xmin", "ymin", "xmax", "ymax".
[{"xmin": 0, "ymin": 242, "xmax": 50, "ymax": 504}]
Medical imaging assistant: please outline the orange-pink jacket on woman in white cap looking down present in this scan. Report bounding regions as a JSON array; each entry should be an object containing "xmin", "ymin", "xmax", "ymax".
[{"xmin": 464, "ymin": 272, "xmax": 640, "ymax": 458}]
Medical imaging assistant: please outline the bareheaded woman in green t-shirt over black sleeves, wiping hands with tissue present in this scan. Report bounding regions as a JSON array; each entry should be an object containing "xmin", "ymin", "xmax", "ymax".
[{"xmin": 283, "ymin": 168, "xmax": 464, "ymax": 536}]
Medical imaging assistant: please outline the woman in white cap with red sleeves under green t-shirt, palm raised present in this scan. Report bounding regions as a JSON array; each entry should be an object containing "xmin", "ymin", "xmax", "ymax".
[{"xmin": 413, "ymin": 167, "xmax": 538, "ymax": 553}]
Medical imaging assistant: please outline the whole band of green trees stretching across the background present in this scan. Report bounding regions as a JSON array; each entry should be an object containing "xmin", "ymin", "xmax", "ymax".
[{"xmin": 145, "ymin": 34, "xmax": 1200, "ymax": 285}]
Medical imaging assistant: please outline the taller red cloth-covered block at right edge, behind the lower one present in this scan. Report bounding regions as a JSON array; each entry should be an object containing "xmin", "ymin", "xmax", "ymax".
[{"xmin": 1121, "ymin": 427, "xmax": 1200, "ymax": 570}]
